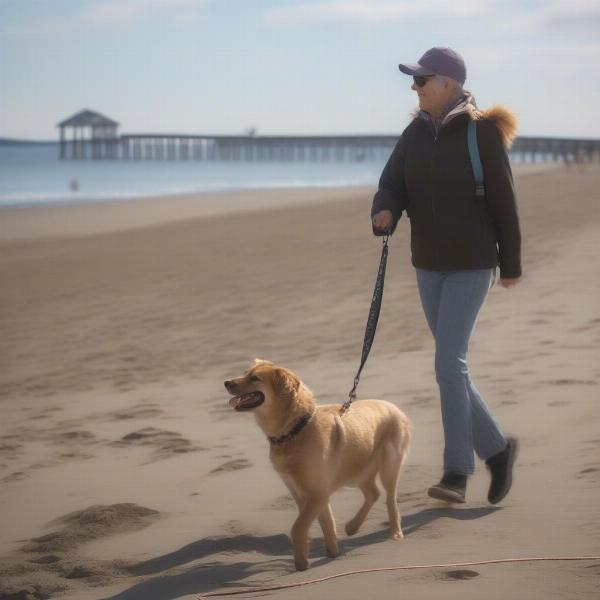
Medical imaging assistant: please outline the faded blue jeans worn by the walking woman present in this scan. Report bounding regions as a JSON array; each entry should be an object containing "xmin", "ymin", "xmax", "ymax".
[{"xmin": 416, "ymin": 268, "xmax": 507, "ymax": 475}]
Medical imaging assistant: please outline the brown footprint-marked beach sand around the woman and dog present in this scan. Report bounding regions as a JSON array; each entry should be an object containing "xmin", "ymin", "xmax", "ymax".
[{"xmin": 0, "ymin": 168, "xmax": 600, "ymax": 600}]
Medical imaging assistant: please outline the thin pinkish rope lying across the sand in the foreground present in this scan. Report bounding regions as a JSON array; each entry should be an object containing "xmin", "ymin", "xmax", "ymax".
[{"xmin": 198, "ymin": 556, "xmax": 600, "ymax": 600}]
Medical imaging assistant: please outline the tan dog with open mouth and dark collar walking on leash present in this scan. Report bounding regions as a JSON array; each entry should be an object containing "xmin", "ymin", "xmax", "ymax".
[{"xmin": 225, "ymin": 359, "xmax": 410, "ymax": 571}]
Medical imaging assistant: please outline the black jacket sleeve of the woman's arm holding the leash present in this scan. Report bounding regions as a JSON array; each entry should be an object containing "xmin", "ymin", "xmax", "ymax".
[{"xmin": 371, "ymin": 130, "xmax": 408, "ymax": 235}]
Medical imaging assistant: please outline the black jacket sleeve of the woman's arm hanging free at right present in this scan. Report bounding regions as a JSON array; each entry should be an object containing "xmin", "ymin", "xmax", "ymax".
[{"xmin": 477, "ymin": 120, "xmax": 521, "ymax": 278}]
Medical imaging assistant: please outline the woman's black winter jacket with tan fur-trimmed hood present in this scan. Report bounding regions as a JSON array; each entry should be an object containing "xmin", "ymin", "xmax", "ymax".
[{"xmin": 371, "ymin": 103, "xmax": 521, "ymax": 278}]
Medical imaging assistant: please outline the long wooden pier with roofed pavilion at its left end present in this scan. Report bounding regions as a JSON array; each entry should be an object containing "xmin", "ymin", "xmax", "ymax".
[{"xmin": 58, "ymin": 110, "xmax": 600, "ymax": 162}]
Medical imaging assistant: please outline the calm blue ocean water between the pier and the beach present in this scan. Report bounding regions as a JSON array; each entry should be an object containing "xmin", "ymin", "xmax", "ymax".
[{"xmin": 0, "ymin": 143, "xmax": 391, "ymax": 207}]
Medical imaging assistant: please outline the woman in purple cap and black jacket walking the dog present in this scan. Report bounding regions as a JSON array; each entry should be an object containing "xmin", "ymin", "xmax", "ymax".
[{"xmin": 371, "ymin": 47, "xmax": 521, "ymax": 504}]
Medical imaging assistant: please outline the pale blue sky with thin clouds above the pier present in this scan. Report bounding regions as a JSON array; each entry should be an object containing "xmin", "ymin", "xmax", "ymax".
[{"xmin": 0, "ymin": 0, "xmax": 600, "ymax": 139}]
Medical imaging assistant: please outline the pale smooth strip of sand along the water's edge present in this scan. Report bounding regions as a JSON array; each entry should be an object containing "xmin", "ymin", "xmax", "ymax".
[{"xmin": 0, "ymin": 163, "xmax": 561, "ymax": 243}]
